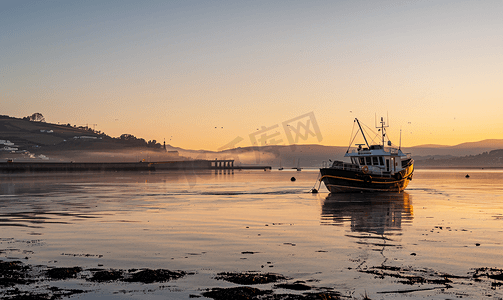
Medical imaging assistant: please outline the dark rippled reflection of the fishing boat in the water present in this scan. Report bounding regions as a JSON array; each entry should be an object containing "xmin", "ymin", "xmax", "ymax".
[{"xmin": 321, "ymin": 192, "xmax": 413, "ymax": 235}]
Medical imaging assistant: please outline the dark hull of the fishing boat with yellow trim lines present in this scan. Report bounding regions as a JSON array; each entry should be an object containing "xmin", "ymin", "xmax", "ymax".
[{"xmin": 320, "ymin": 163, "xmax": 414, "ymax": 193}]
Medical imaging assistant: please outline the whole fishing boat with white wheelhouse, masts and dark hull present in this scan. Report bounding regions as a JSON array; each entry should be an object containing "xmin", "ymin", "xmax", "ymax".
[{"xmin": 320, "ymin": 118, "xmax": 414, "ymax": 193}]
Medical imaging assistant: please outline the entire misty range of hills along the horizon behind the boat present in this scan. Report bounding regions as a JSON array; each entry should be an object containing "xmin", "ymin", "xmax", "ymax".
[{"xmin": 0, "ymin": 116, "xmax": 503, "ymax": 168}]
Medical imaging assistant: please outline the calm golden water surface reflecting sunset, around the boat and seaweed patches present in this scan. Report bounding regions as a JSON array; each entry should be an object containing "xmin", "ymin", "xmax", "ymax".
[{"xmin": 0, "ymin": 170, "xmax": 503, "ymax": 299}]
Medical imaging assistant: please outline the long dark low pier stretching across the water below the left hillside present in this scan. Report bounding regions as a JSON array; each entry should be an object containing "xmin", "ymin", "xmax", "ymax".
[{"xmin": 0, "ymin": 159, "xmax": 271, "ymax": 173}]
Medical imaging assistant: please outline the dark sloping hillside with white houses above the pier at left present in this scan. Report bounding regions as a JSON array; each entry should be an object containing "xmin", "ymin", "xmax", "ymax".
[{"xmin": 0, "ymin": 116, "xmax": 179, "ymax": 161}]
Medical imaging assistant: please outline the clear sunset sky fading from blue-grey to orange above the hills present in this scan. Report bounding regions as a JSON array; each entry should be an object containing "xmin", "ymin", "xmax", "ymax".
[{"xmin": 0, "ymin": 0, "xmax": 503, "ymax": 150}]
